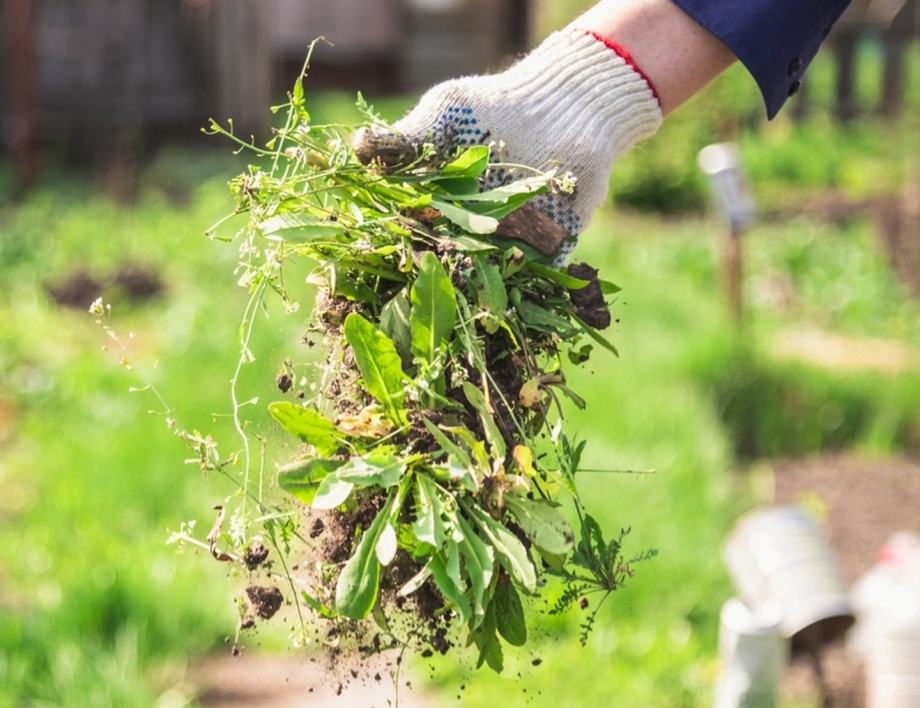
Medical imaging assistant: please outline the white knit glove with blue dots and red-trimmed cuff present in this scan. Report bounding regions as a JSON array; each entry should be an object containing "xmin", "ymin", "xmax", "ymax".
[{"xmin": 355, "ymin": 29, "xmax": 661, "ymax": 258}]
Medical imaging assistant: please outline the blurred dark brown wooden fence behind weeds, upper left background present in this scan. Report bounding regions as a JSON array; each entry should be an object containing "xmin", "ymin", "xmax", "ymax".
[{"xmin": 0, "ymin": 0, "xmax": 531, "ymax": 176}]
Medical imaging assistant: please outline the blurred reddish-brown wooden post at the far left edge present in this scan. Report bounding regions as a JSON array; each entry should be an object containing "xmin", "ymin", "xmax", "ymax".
[{"xmin": 7, "ymin": 0, "xmax": 38, "ymax": 192}]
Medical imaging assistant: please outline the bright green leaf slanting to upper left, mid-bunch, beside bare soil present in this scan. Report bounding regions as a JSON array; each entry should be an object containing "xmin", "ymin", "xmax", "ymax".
[{"xmin": 345, "ymin": 312, "xmax": 409, "ymax": 425}]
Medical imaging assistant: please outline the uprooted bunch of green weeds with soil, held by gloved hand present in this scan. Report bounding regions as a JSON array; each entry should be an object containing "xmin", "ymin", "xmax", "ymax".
[{"xmin": 180, "ymin": 54, "xmax": 650, "ymax": 671}]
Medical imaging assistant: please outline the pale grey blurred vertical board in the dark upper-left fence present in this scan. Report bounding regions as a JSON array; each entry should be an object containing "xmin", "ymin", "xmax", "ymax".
[{"xmin": 212, "ymin": 0, "xmax": 272, "ymax": 140}]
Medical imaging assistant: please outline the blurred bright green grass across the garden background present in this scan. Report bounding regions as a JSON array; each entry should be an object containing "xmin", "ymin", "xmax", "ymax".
[{"xmin": 0, "ymin": 51, "xmax": 920, "ymax": 708}]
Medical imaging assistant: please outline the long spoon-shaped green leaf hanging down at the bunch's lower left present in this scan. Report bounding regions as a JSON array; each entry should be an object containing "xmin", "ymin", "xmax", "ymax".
[{"xmin": 335, "ymin": 490, "xmax": 398, "ymax": 619}]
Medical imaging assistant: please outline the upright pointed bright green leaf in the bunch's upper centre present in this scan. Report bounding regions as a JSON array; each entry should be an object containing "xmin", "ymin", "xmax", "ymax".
[{"xmin": 409, "ymin": 251, "xmax": 457, "ymax": 363}]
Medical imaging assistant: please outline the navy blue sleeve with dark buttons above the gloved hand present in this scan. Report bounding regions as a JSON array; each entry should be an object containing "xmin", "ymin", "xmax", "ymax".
[{"xmin": 673, "ymin": 0, "xmax": 850, "ymax": 118}]
